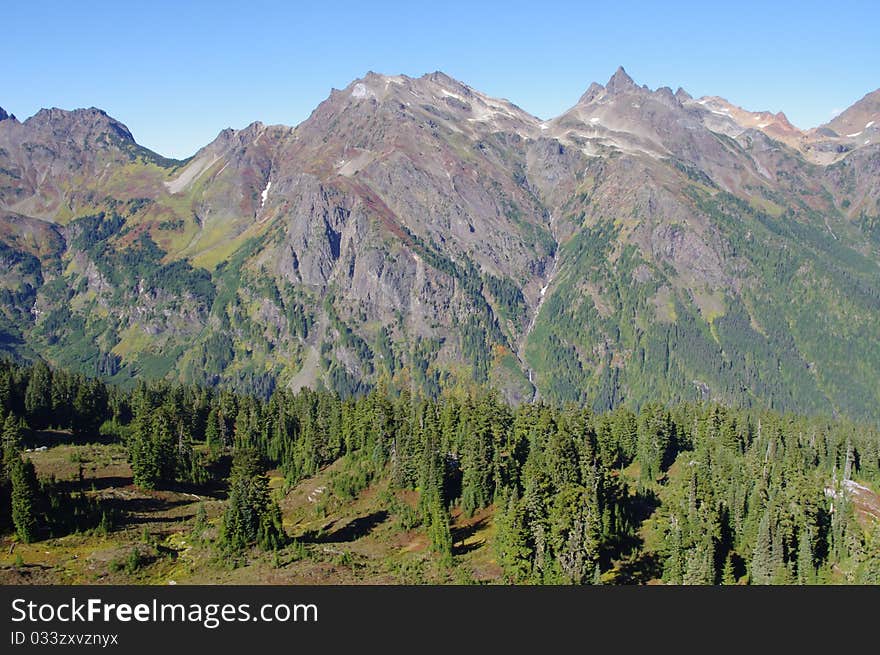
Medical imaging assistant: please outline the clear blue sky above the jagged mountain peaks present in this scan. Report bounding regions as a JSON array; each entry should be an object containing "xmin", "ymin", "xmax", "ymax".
[{"xmin": 0, "ymin": 0, "xmax": 880, "ymax": 157}]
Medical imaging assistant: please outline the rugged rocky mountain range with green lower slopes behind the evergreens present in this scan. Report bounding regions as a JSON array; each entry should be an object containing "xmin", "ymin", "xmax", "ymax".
[{"xmin": 0, "ymin": 68, "xmax": 880, "ymax": 421}]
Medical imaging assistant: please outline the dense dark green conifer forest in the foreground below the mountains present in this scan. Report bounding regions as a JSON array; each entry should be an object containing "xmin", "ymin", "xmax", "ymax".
[{"xmin": 0, "ymin": 362, "xmax": 880, "ymax": 584}]
